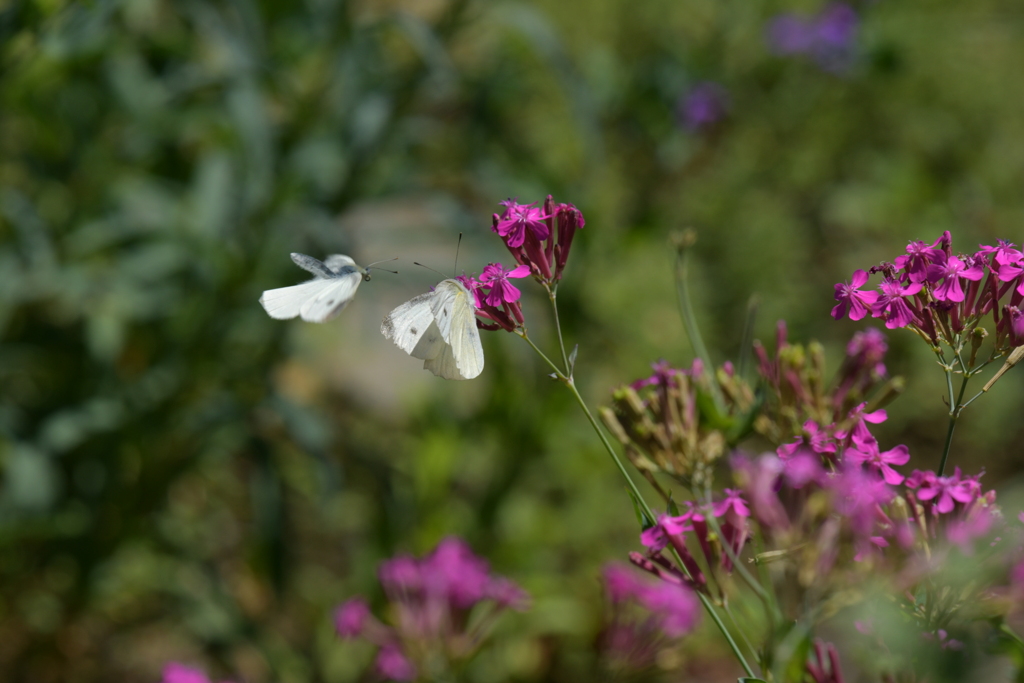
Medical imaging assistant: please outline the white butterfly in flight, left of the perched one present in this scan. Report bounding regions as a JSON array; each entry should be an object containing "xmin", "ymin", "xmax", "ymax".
[{"xmin": 259, "ymin": 254, "xmax": 370, "ymax": 323}]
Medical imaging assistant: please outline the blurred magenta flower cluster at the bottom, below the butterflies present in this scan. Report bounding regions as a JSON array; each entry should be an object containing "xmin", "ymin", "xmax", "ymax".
[{"xmin": 335, "ymin": 538, "xmax": 529, "ymax": 681}]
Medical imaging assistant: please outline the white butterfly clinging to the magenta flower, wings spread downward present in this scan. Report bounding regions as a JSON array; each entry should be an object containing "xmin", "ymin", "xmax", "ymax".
[{"xmin": 381, "ymin": 280, "xmax": 483, "ymax": 380}]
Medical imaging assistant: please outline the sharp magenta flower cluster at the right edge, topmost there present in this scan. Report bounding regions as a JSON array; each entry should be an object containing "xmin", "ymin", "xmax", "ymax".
[{"xmin": 833, "ymin": 231, "xmax": 1024, "ymax": 349}]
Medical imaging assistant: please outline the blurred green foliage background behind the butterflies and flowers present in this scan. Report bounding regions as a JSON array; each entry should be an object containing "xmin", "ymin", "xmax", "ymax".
[{"xmin": 0, "ymin": 0, "xmax": 1024, "ymax": 683}]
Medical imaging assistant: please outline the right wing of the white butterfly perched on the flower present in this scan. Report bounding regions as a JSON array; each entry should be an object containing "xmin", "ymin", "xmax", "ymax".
[{"xmin": 423, "ymin": 280, "xmax": 483, "ymax": 380}]
